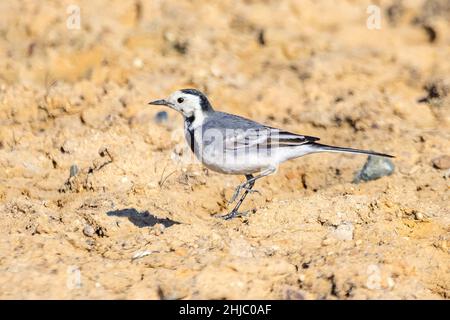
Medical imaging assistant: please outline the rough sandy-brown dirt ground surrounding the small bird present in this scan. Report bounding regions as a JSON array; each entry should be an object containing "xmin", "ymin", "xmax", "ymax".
[{"xmin": 0, "ymin": 0, "xmax": 450, "ymax": 299}]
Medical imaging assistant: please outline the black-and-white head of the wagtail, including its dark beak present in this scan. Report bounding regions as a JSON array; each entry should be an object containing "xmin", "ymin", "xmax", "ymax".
[{"xmin": 149, "ymin": 89, "xmax": 213, "ymax": 118}]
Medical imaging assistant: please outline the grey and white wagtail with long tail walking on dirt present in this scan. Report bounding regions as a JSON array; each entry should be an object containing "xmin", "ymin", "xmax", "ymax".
[{"xmin": 149, "ymin": 89, "xmax": 393, "ymax": 220}]
